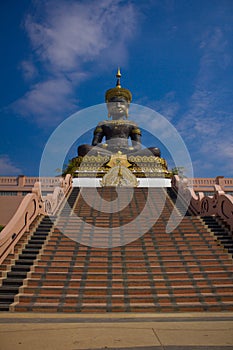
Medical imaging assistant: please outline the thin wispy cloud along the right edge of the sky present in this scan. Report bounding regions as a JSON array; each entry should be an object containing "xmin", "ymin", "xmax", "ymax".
[{"xmin": 177, "ymin": 27, "xmax": 233, "ymax": 176}]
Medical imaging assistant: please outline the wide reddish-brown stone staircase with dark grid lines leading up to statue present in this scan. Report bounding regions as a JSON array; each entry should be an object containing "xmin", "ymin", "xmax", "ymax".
[{"xmin": 0, "ymin": 188, "xmax": 233, "ymax": 312}]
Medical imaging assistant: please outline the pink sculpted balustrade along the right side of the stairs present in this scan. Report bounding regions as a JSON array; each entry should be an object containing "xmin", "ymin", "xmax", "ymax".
[{"xmin": 171, "ymin": 175, "xmax": 233, "ymax": 232}]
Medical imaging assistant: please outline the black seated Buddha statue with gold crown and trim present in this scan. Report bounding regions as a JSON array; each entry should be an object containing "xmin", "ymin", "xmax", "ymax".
[{"xmin": 78, "ymin": 69, "xmax": 160, "ymax": 157}]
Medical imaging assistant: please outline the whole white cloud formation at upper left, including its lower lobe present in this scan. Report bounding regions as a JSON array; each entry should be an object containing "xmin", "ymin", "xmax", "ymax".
[{"xmin": 12, "ymin": 0, "xmax": 137, "ymax": 126}]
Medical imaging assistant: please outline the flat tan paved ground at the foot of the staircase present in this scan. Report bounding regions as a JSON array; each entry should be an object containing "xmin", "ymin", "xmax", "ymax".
[{"xmin": 0, "ymin": 312, "xmax": 233, "ymax": 350}]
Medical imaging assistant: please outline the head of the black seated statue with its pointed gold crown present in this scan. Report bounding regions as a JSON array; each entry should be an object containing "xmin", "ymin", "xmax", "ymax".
[{"xmin": 105, "ymin": 68, "xmax": 132, "ymax": 120}]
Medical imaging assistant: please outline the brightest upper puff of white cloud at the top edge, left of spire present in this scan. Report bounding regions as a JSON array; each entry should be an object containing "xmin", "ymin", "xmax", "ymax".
[{"xmin": 25, "ymin": 0, "xmax": 136, "ymax": 71}]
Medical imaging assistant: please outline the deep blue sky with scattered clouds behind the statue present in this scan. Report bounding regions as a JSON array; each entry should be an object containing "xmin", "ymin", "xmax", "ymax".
[{"xmin": 0, "ymin": 0, "xmax": 233, "ymax": 177}]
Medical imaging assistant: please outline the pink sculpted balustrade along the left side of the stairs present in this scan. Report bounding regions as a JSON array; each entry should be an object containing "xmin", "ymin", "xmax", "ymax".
[{"xmin": 0, "ymin": 174, "xmax": 72, "ymax": 264}]
